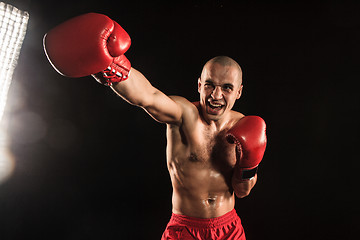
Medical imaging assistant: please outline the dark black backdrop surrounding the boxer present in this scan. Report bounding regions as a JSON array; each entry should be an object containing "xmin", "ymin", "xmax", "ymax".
[{"xmin": 0, "ymin": 0, "xmax": 360, "ymax": 240}]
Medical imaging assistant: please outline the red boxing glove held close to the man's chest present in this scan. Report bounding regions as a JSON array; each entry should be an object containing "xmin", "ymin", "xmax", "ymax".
[{"xmin": 226, "ymin": 116, "xmax": 266, "ymax": 181}]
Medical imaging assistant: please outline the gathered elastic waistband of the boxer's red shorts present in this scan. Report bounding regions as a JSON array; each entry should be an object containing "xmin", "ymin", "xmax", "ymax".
[{"xmin": 170, "ymin": 209, "xmax": 240, "ymax": 228}]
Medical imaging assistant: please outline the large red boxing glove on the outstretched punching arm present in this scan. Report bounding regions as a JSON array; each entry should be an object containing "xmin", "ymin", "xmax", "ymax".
[{"xmin": 43, "ymin": 13, "xmax": 131, "ymax": 85}]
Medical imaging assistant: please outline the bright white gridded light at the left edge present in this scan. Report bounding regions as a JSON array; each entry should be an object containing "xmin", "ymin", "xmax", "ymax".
[{"xmin": 0, "ymin": 2, "xmax": 29, "ymax": 182}]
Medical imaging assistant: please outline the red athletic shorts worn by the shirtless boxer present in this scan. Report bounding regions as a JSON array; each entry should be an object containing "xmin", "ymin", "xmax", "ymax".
[{"xmin": 161, "ymin": 209, "xmax": 245, "ymax": 240}]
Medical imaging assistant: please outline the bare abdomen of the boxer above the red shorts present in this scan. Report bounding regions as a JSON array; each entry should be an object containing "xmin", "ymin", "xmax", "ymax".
[{"xmin": 169, "ymin": 153, "xmax": 235, "ymax": 218}]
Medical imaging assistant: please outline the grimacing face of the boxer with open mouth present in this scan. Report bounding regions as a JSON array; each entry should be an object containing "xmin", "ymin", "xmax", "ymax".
[{"xmin": 198, "ymin": 63, "xmax": 242, "ymax": 121}]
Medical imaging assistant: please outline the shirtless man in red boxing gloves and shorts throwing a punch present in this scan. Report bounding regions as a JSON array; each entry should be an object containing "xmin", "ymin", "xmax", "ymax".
[{"xmin": 44, "ymin": 13, "xmax": 266, "ymax": 239}]
